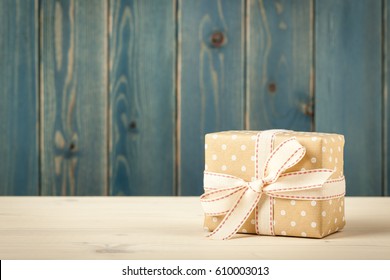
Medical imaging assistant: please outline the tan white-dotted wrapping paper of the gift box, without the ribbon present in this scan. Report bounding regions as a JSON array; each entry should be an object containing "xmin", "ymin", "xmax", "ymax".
[{"xmin": 204, "ymin": 131, "xmax": 345, "ymax": 238}]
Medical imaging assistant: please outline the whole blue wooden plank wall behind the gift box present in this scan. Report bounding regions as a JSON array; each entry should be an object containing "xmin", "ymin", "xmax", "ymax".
[{"xmin": 0, "ymin": 0, "xmax": 390, "ymax": 195}]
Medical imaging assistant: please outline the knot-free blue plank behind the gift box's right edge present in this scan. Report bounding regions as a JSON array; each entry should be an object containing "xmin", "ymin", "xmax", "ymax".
[{"xmin": 315, "ymin": 0, "xmax": 382, "ymax": 195}]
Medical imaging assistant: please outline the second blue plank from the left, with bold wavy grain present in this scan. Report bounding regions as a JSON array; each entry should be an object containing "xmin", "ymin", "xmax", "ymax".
[{"xmin": 40, "ymin": 0, "xmax": 108, "ymax": 195}]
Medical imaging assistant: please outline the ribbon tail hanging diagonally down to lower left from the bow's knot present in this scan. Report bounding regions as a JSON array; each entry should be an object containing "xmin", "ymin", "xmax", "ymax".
[{"xmin": 209, "ymin": 188, "xmax": 261, "ymax": 239}]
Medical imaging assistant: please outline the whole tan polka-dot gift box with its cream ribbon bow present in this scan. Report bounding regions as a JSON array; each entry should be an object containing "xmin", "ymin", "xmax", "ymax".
[{"xmin": 201, "ymin": 130, "xmax": 345, "ymax": 239}]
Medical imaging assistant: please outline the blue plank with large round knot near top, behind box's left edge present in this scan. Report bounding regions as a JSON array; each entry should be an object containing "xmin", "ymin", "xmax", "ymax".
[{"xmin": 178, "ymin": 0, "xmax": 244, "ymax": 195}]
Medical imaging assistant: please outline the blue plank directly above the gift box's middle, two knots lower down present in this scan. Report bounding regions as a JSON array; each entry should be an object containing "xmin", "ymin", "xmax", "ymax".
[{"xmin": 246, "ymin": 0, "xmax": 313, "ymax": 131}]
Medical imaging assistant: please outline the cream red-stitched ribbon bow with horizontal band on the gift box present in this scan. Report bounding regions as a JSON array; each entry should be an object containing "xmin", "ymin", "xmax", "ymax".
[{"xmin": 200, "ymin": 137, "xmax": 345, "ymax": 239}]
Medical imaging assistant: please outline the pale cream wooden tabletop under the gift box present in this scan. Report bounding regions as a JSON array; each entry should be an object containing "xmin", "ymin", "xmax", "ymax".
[{"xmin": 0, "ymin": 197, "xmax": 390, "ymax": 259}]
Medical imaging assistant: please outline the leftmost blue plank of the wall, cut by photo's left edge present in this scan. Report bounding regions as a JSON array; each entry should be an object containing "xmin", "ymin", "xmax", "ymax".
[{"xmin": 0, "ymin": 0, "xmax": 39, "ymax": 195}]
